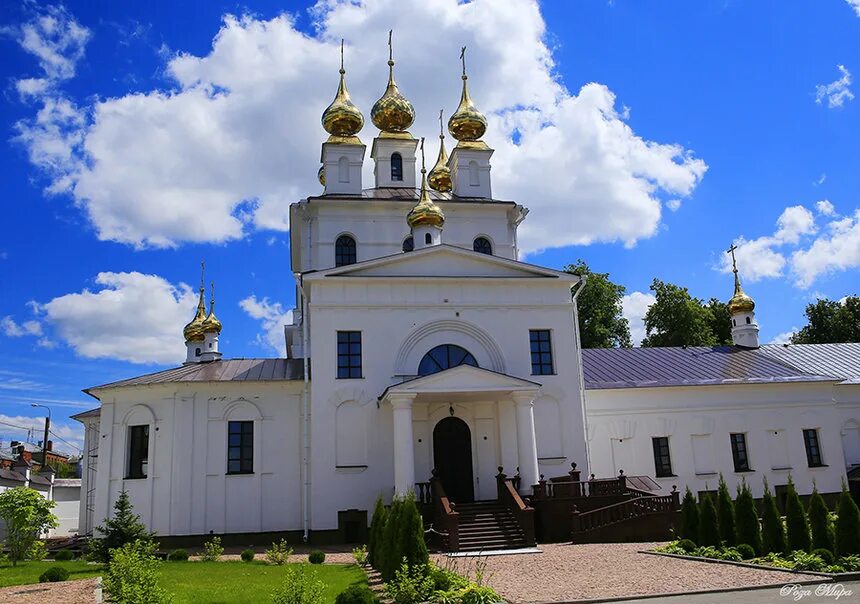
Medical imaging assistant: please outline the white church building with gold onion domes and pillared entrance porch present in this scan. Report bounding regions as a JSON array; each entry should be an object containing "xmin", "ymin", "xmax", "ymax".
[{"xmin": 72, "ymin": 44, "xmax": 860, "ymax": 549}]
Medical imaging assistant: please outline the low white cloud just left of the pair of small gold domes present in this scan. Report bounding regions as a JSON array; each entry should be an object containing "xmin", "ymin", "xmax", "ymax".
[{"xmin": 40, "ymin": 272, "xmax": 196, "ymax": 364}]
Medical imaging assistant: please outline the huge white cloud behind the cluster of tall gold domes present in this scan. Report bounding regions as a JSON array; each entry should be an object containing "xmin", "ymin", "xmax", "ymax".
[{"xmin": 11, "ymin": 0, "xmax": 707, "ymax": 251}]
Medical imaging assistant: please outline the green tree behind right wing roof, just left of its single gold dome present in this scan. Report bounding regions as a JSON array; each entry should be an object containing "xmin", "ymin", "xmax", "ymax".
[{"xmin": 642, "ymin": 279, "xmax": 717, "ymax": 347}]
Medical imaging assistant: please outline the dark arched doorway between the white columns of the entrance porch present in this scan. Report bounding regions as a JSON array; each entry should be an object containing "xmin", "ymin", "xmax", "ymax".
[{"xmin": 433, "ymin": 417, "xmax": 475, "ymax": 503}]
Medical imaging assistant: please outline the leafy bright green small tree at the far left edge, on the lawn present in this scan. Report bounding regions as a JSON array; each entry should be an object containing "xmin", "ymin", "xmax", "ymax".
[{"xmin": 0, "ymin": 487, "xmax": 57, "ymax": 566}]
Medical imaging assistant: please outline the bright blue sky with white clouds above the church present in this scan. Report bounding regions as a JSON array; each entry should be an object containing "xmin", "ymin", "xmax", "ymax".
[{"xmin": 0, "ymin": 0, "xmax": 860, "ymax": 452}]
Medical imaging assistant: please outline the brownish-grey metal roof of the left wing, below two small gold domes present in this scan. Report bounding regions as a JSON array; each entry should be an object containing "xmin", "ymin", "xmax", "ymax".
[{"xmin": 84, "ymin": 359, "xmax": 304, "ymax": 398}]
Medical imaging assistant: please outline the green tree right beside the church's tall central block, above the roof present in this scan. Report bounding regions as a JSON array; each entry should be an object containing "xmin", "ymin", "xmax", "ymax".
[{"xmin": 564, "ymin": 260, "xmax": 632, "ymax": 348}]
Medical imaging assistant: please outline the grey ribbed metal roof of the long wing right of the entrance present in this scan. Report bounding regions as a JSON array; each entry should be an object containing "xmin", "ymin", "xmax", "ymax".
[{"xmin": 582, "ymin": 344, "xmax": 844, "ymax": 390}]
